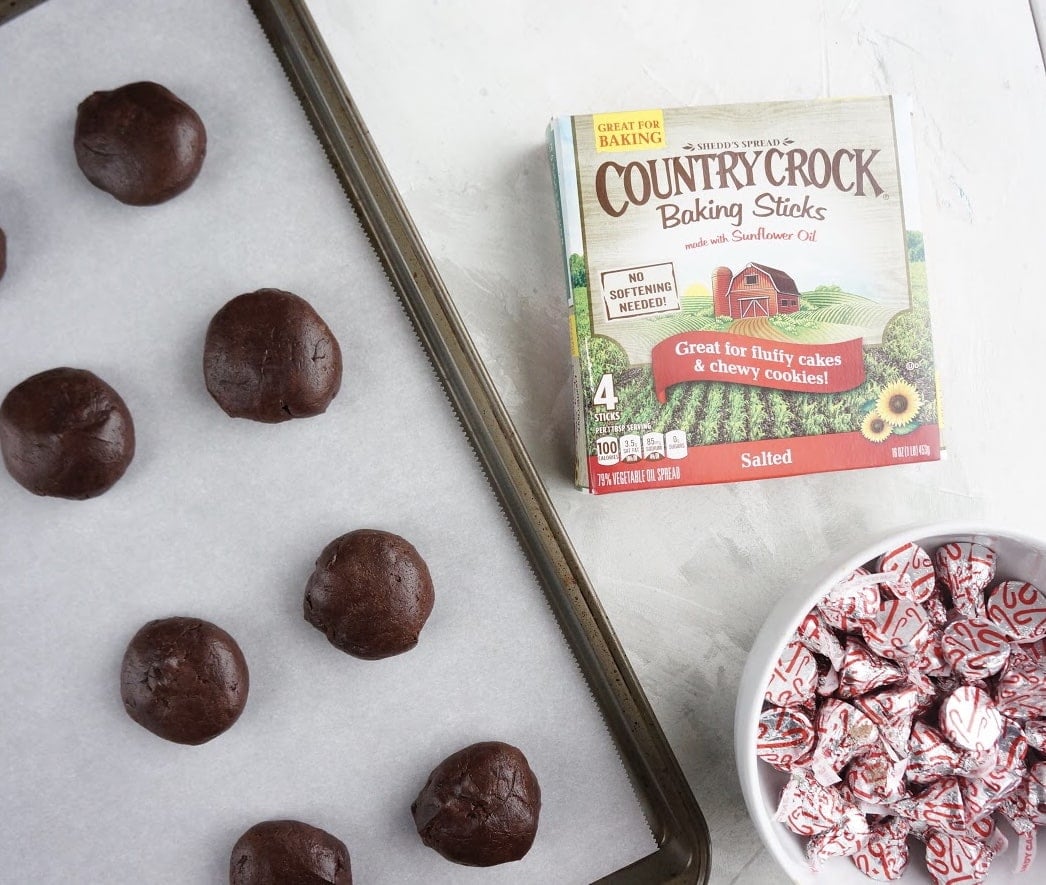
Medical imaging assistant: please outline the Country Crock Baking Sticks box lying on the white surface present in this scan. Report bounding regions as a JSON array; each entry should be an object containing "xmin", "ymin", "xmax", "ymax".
[{"xmin": 548, "ymin": 96, "xmax": 940, "ymax": 494}]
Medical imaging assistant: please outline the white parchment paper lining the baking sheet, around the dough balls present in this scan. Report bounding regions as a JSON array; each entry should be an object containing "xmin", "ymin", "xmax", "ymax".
[{"xmin": 0, "ymin": 0, "xmax": 656, "ymax": 883}]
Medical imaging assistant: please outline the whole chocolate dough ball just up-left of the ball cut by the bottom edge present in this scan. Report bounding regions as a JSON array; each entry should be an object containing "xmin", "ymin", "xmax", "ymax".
[{"xmin": 120, "ymin": 617, "xmax": 250, "ymax": 744}]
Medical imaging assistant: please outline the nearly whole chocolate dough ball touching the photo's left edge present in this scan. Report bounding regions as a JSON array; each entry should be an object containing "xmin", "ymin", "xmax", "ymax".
[{"xmin": 0, "ymin": 368, "xmax": 134, "ymax": 499}]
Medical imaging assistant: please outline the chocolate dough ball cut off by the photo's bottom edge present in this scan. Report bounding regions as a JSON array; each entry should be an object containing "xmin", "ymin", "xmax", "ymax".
[{"xmin": 229, "ymin": 820, "xmax": 353, "ymax": 885}]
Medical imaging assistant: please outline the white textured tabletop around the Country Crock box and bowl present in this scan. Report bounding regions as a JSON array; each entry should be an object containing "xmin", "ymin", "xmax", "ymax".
[{"xmin": 311, "ymin": 0, "xmax": 1046, "ymax": 883}]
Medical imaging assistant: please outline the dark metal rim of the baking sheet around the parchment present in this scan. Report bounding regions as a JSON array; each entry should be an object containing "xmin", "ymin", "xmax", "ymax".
[{"xmin": 0, "ymin": 0, "xmax": 710, "ymax": 885}]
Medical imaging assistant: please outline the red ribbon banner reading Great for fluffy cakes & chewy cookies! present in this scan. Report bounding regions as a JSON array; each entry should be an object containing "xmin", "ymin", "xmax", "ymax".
[{"xmin": 651, "ymin": 332, "xmax": 864, "ymax": 403}]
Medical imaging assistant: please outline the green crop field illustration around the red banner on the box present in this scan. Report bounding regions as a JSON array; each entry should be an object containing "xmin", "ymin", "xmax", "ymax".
[{"xmin": 574, "ymin": 239, "xmax": 937, "ymax": 446}]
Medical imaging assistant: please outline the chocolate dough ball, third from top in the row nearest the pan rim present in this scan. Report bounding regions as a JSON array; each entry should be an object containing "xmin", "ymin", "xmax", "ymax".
[{"xmin": 305, "ymin": 528, "xmax": 434, "ymax": 660}]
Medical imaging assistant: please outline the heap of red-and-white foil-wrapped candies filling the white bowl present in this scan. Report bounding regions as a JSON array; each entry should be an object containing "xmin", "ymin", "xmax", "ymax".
[{"xmin": 758, "ymin": 542, "xmax": 1046, "ymax": 885}]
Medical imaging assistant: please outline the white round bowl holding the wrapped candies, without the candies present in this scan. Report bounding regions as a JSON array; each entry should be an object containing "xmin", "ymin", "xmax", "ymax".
[{"xmin": 734, "ymin": 523, "xmax": 1046, "ymax": 885}]
